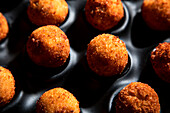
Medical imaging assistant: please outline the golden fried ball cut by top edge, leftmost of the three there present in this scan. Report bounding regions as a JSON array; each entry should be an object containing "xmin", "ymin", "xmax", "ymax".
[{"xmin": 27, "ymin": 0, "xmax": 68, "ymax": 26}]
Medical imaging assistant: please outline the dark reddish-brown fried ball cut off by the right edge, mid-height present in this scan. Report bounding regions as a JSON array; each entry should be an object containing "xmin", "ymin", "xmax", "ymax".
[{"xmin": 150, "ymin": 42, "xmax": 170, "ymax": 83}]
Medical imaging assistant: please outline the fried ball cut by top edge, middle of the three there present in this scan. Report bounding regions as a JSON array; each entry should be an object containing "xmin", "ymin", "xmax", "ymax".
[{"xmin": 85, "ymin": 0, "xmax": 124, "ymax": 31}]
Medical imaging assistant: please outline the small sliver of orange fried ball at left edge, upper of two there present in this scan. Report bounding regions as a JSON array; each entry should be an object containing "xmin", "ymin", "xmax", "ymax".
[{"xmin": 0, "ymin": 12, "xmax": 9, "ymax": 41}]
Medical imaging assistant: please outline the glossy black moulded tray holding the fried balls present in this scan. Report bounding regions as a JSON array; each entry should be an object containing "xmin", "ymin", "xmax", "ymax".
[{"xmin": 0, "ymin": 0, "xmax": 170, "ymax": 113}]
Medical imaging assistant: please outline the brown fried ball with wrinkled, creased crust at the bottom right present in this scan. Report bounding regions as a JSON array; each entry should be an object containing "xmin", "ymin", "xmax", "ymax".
[{"xmin": 116, "ymin": 82, "xmax": 160, "ymax": 113}]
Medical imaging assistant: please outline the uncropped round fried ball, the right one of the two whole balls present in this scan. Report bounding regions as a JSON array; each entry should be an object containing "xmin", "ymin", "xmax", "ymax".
[{"xmin": 87, "ymin": 34, "xmax": 128, "ymax": 76}]
